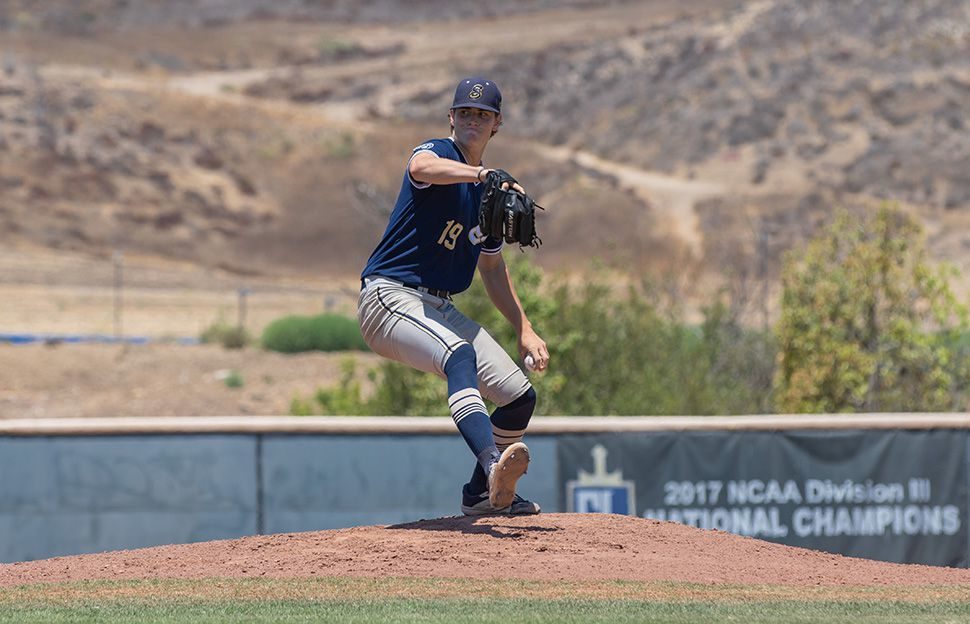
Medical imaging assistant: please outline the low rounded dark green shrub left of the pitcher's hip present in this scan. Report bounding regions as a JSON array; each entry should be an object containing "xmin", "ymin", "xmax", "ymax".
[{"xmin": 262, "ymin": 314, "xmax": 367, "ymax": 353}]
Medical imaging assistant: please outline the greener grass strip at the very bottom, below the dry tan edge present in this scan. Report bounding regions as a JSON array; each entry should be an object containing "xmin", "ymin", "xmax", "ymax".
[{"xmin": 0, "ymin": 598, "xmax": 970, "ymax": 624}]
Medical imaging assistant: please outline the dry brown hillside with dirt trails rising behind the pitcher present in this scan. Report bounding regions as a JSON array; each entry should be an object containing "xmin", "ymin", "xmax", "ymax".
[{"xmin": 0, "ymin": 0, "xmax": 970, "ymax": 312}]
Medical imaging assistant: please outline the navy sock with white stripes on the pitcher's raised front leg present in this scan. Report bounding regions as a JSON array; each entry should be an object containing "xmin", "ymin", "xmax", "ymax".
[{"xmin": 445, "ymin": 343, "xmax": 499, "ymax": 474}]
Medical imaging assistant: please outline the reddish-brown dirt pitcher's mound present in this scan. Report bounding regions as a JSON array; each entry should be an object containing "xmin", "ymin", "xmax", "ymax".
[{"xmin": 0, "ymin": 514, "xmax": 970, "ymax": 587}]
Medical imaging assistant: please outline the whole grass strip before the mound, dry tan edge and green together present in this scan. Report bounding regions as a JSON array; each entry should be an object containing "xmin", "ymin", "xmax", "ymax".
[{"xmin": 0, "ymin": 578, "xmax": 970, "ymax": 624}]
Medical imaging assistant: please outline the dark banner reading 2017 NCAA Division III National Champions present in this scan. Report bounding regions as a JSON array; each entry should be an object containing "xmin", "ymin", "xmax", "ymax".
[{"xmin": 557, "ymin": 429, "xmax": 970, "ymax": 567}]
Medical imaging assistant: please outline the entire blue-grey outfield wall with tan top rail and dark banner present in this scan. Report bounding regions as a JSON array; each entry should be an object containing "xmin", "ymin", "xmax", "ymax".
[{"xmin": 0, "ymin": 413, "xmax": 970, "ymax": 567}]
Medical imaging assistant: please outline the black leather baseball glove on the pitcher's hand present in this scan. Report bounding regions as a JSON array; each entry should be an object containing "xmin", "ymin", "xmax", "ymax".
[{"xmin": 478, "ymin": 169, "xmax": 545, "ymax": 247}]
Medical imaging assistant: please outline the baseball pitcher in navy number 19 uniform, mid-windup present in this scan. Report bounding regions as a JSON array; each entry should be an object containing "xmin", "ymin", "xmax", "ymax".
[{"xmin": 357, "ymin": 77, "xmax": 549, "ymax": 515}]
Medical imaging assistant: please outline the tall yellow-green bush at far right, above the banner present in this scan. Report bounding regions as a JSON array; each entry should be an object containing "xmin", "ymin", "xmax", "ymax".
[{"xmin": 776, "ymin": 205, "xmax": 970, "ymax": 412}]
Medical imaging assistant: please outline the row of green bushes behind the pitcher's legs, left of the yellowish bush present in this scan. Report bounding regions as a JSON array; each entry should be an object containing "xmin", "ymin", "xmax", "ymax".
[{"xmin": 304, "ymin": 254, "xmax": 777, "ymax": 416}]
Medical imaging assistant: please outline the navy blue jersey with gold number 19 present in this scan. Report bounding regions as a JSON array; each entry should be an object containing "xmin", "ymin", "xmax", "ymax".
[{"xmin": 361, "ymin": 138, "xmax": 502, "ymax": 293}]
